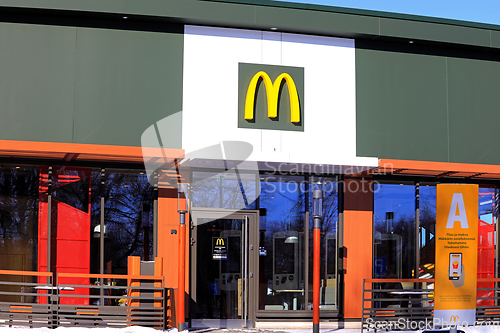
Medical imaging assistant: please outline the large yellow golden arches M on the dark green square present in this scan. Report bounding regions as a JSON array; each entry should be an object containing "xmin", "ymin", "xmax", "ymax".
[{"xmin": 245, "ymin": 71, "xmax": 300, "ymax": 123}]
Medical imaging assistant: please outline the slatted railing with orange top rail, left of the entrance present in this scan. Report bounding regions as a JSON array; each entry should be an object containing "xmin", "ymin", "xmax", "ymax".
[{"xmin": 0, "ymin": 270, "xmax": 173, "ymax": 329}]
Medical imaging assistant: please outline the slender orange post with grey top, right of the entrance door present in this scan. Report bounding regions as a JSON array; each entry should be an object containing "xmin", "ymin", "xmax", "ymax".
[{"xmin": 313, "ymin": 190, "xmax": 323, "ymax": 333}]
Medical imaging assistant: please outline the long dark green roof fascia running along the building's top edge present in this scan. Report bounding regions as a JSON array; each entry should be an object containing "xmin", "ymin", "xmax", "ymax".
[{"xmin": 0, "ymin": 0, "xmax": 500, "ymax": 51}]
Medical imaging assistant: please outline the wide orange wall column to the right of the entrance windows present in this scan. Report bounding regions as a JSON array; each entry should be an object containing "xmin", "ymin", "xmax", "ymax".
[{"xmin": 344, "ymin": 178, "xmax": 373, "ymax": 318}]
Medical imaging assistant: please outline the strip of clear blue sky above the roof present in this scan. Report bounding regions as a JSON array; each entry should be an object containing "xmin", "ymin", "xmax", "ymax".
[{"xmin": 274, "ymin": 0, "xmax": 500, "ymax": 24}]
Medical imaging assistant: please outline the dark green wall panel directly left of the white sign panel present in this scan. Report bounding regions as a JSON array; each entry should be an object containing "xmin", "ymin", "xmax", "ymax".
[{"xmin": 74, "ymin": 28, "xmax": 183, "ymax": 148}]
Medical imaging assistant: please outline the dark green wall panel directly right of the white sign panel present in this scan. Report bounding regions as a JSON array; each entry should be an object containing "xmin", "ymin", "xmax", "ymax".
[{"xmin": 356, "ymin": 43, "xmax": 448, "ymax": 161}]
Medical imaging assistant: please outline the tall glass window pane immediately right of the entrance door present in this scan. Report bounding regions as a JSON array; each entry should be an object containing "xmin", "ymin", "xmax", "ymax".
[{"xmin": 259, "ymin": 175, "xmax": 307, "ymax": 310}]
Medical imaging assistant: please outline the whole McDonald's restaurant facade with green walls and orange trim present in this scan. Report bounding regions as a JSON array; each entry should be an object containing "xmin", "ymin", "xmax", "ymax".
[{"xmin": 0, "ymin": 0, "xmax": 500, "ymax": 327}]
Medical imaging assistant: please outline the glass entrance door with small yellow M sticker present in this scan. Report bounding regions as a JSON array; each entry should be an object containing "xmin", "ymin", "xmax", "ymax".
[{"xmin": 190, "ymin": 211, "xmax": 257, "ymax": 328}]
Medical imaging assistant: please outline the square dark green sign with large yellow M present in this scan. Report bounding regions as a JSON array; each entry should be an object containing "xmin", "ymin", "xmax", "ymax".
[{"xmin": 238, "ymin": 63, "xmax": 304, "ymax": 132}]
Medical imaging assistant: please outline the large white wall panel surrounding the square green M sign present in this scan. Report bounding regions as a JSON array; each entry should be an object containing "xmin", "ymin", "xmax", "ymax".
[{"xmin": 182, "ymin": 26, "xmax": 378, "ymax": 166}]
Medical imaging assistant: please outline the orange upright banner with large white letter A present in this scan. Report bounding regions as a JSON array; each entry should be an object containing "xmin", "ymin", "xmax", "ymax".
[{"xmin": 434, "ymin": 184, "xmax": 479, "ymax": 326}]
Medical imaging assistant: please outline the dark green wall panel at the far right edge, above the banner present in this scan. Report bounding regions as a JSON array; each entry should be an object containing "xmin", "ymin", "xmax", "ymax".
[{"xmin": 448, "ymin": 58, "xmax": 500, "ymax": 164}]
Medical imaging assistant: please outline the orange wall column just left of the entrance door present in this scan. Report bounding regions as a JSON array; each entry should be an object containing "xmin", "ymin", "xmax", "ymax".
[{"xmin": 158, "ymin": 188, "xmax": 190, "ymax": 327}]
